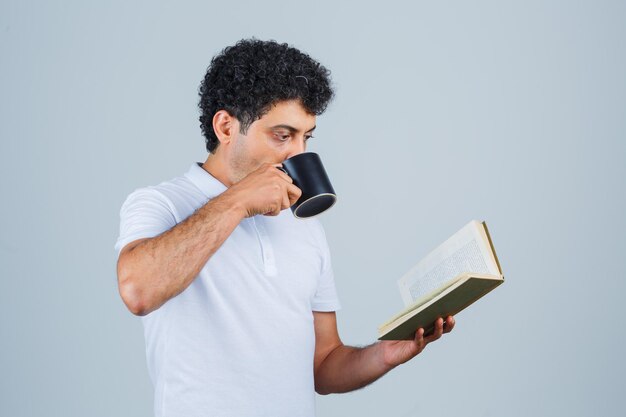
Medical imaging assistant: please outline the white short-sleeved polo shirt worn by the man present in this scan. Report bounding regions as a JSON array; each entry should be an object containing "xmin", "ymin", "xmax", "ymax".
[{"xmin": 115, "ymin": 163, "xmax": 340, "ymax": 417}]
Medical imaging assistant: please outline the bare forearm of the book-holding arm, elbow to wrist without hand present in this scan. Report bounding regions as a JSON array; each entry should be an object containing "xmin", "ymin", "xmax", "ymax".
[{"xmin": 315, "ymin": 343, "xmax": 393, "ymax": 394}]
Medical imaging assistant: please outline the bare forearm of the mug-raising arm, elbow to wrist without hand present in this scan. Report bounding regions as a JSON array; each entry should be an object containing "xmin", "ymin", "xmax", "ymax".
[{"xmin": 118, "ymin": 192, "xmax": 244, "ymax": 315}]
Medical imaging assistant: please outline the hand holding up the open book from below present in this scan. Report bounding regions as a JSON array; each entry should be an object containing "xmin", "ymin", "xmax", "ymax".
[{"xmin": 380, "ymin": 316, "xmax": 454, "ymax": 367}]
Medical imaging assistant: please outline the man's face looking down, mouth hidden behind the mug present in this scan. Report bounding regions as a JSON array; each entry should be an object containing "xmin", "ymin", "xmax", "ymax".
[{"xmin": 227, "ymin": 100, "xmax": 315, "ymax": 183}]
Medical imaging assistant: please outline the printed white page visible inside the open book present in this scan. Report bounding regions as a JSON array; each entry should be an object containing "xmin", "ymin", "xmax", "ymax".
[{"xmin": 398, "ymin": 220, "xmax": 500, "ymax": 307}]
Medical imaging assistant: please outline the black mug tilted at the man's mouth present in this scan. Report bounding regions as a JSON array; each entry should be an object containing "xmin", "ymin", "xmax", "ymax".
[{"xmin": 278, "ymin": 152, "xmax": 337, "ymax": 219}]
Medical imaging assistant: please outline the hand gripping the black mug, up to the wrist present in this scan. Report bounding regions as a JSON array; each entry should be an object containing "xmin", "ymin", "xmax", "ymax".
[{"xmin": 224, "ymin": 163, "xmax": 302, "ymax": 217}]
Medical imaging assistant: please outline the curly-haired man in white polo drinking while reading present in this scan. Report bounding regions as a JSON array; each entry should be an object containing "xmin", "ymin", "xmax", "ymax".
[{"xmin": 116, "ymin": 39, "xmax": 454, "ymax": 417}]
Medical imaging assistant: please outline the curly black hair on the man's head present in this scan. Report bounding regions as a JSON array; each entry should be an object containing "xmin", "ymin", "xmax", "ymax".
[{"xmin": 198, "ymin": 38, "xmax": 334, "ymax": 153}]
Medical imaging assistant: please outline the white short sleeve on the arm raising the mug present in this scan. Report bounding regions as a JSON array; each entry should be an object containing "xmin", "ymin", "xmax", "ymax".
[{"xmin": 115, "ymin": 188, "xmax": 176, "ymax": 255}]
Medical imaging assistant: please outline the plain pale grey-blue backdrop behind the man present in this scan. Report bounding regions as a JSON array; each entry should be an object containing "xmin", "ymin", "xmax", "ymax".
[{"xmin": 0, "ymin": 0, "xmax": 626, "ymax": 417}]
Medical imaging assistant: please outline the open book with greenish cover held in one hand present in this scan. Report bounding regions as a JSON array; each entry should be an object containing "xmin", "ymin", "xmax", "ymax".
[{"xmin": 378, "ymin": 220, "xmax": 504, "ymax": 340}]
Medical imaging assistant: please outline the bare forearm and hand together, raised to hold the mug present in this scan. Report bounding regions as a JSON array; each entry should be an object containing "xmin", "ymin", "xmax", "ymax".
[{"xmin": 117, "ymin": 164, "xmax": 302, "ymax": 316}]
